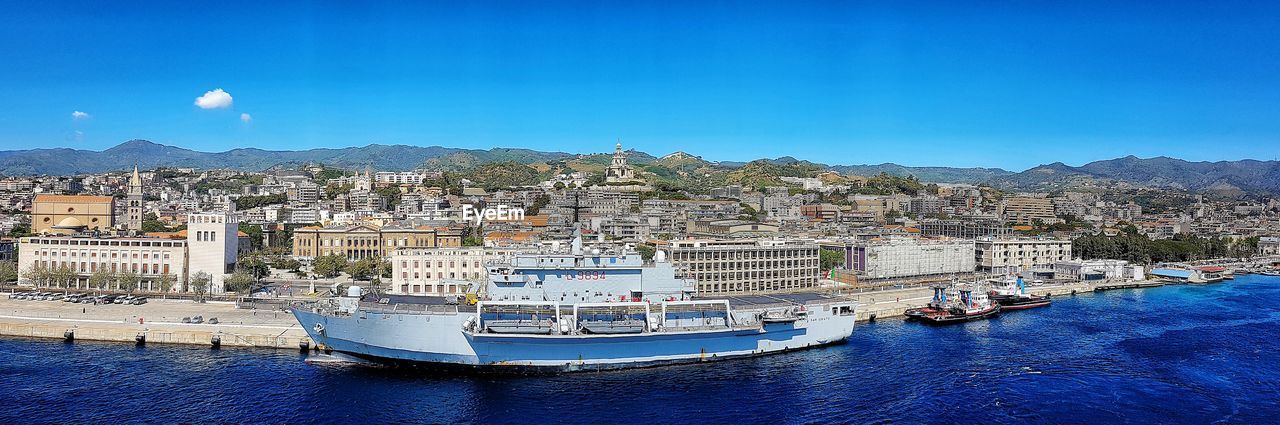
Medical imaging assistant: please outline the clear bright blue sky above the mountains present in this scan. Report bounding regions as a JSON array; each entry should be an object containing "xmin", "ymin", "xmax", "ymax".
[{"xmin": 0, "ymin": 1, "xmax": 1280, "ymax": 170}]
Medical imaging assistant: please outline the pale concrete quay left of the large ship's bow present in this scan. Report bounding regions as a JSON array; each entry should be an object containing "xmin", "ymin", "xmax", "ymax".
[{"xmin": 0, "ymin": 294, "xmax": 315, "ymax": 349}]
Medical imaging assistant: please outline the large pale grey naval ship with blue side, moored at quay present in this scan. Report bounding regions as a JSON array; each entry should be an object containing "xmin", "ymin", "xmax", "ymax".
[{"xmin": 293, "ymin": 238, "xmax": 856, "ymax": 373}]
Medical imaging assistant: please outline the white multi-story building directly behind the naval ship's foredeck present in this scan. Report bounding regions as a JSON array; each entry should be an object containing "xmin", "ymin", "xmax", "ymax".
[{"xmin": 389, "ymin": 247, "xmax": 527, "ymax": 296}]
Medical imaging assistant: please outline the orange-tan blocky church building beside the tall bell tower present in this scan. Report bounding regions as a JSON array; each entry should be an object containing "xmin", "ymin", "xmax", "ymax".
[{"xmin": 31, "ymin": 195, "xmax": 115, "ymax": 234}]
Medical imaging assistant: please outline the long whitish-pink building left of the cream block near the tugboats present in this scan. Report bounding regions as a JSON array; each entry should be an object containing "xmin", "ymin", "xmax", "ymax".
[{"xmin": 819, "ymin": 238, "xmax": 975, "ymax": 279}]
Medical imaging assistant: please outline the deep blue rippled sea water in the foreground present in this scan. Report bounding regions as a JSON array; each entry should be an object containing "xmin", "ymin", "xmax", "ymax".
[{"xmin": 0, "ymin": 277, "xmax": 1280, "ymax": 424}]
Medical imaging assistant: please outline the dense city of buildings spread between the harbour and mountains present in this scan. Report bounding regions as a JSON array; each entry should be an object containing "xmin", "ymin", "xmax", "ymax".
[{"xmin": 0, "ymin": 143, "xmax": 1280, "ymax": 296}]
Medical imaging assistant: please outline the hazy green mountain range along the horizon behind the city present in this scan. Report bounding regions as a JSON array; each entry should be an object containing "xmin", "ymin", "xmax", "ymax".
[{"xmin": 0, "ymin": 140, "xmax": 1280, "ymax": 197}]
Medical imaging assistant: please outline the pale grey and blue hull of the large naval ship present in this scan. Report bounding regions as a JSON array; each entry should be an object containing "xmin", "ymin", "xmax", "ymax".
[{"xmin": 293, "ymin": 310, "xmax": 854, "ymax": 374}]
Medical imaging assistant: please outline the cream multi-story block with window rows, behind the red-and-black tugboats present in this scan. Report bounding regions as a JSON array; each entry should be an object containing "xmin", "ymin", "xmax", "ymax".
[{"xmin": 974, "ymin": 238, "xmax": 1071, "ymax": 274}]
